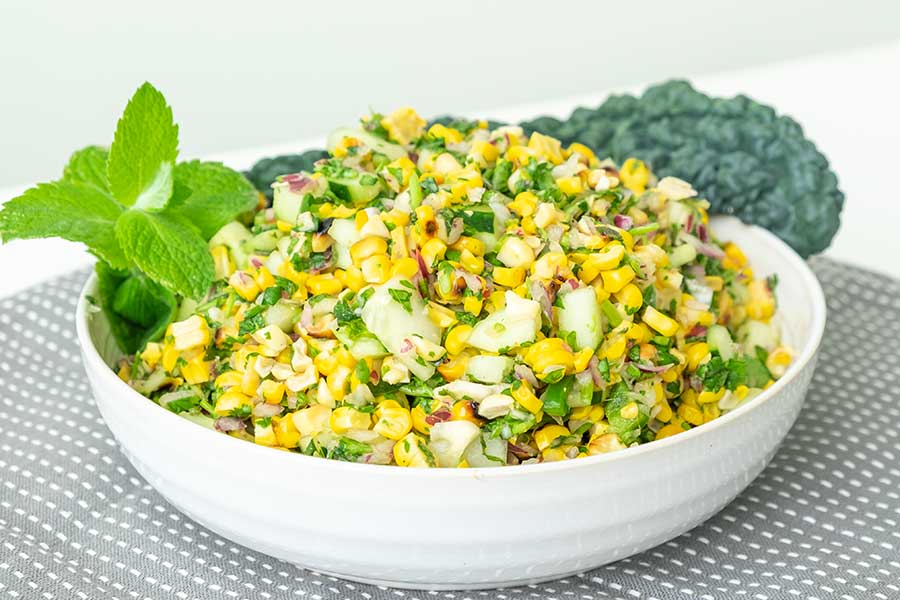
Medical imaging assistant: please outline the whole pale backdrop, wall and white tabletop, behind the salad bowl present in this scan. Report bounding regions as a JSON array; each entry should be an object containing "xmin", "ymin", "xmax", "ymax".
[{"xmin": 0, "ymin": 0, "xmax": 900, "ymax": 295}]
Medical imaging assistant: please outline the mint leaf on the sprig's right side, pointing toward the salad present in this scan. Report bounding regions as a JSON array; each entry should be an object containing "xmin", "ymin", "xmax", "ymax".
[{"xmin": 169, "ymin": 160, "xmax": 259, "ymax": 239}]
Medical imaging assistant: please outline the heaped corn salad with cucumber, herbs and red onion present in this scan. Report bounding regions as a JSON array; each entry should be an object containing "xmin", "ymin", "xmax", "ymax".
[{"xmin": 120, "ymin": 108, "xmax": 791, "ymax": 467}]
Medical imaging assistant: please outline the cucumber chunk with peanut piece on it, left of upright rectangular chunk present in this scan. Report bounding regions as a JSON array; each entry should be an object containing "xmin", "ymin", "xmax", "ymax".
[{"xmin": 469, "ymin": 291, "xmax": 541, "ymax": 352}]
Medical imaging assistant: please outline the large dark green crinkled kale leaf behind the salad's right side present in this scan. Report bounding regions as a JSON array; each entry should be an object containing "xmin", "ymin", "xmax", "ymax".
[{"xmin": 522, "ymin": 81, "xmax": 844, "ymax": 257}]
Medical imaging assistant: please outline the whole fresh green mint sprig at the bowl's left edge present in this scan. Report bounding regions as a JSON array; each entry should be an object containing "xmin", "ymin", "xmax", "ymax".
[{"xmin": 0, "ymin": 83, "xmax": 259, "ymax": 353}]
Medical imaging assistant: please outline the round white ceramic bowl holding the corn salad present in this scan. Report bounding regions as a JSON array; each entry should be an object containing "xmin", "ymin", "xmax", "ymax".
[{"xmin": 77, "ymin": 218, "xmax": 825, "ymax": 589}]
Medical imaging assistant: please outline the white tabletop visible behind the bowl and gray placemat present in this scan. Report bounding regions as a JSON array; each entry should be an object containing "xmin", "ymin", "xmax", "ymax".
[{"xmin": 0, "ymin": 42, "xmax": 900, "ymax": 296}]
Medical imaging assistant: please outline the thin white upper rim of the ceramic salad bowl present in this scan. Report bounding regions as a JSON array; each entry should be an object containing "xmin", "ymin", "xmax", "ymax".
[{"xmin": 75, "ymin": 217, "xmax": 826, "ymax": 480}]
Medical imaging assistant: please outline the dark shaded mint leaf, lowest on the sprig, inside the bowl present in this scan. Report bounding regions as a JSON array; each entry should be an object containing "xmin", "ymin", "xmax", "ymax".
[{"xmin": 95, "ymin": 262, "xmax": 178, "ymax": 354}]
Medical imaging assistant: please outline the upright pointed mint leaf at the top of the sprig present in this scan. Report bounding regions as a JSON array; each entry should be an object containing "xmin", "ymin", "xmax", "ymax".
[{"xmin": 107, "ymin": 83, "xmax": 178, "ymax": 210}]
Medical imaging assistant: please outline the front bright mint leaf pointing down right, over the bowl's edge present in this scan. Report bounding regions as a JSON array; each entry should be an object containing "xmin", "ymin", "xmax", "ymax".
[{"xmin": 116, "ymin": 210, "xmax": 215, "ymax": 299}]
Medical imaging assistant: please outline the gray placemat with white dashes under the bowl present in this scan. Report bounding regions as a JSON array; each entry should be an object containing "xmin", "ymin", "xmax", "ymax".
[{"xmin": 0, "ymin": 259, "xmax": 900, "ymax": 600}]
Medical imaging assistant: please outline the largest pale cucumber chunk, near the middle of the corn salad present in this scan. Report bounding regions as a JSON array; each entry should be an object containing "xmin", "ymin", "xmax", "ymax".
[{"xmin": 360, "ymin": 277, "xmax": 441, "ymax": 380}]
